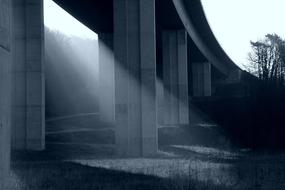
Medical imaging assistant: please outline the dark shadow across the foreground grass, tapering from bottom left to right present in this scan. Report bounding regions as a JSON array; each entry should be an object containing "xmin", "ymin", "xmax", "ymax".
[{"xmin": 9, "ymin": 162, "xmax": 232, "ymax": 190}]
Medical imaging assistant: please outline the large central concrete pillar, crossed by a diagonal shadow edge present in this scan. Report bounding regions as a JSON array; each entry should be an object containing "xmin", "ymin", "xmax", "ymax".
[{"xmin": 114, "ymin": 0, "xmax": 157, "ymax": 156}]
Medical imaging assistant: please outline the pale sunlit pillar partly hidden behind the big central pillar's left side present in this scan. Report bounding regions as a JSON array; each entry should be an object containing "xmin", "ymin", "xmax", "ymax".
[{"xmin": 98, "ymin": 33, "xmax": 115, "ymax": 125}]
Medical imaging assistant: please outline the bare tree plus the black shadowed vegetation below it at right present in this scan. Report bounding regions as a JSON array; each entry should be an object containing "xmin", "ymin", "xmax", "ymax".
[{"xmin": 195, "ymin": 34, "xmax": 285, "ymax": 151}]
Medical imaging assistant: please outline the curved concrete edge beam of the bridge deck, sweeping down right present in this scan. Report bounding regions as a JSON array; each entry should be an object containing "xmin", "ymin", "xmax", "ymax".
[{"xmin": 172, "ymin": 0, "xmax": 240, "ymax": 75}]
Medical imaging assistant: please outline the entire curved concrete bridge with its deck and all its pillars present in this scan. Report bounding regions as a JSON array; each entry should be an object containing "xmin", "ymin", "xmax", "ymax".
[{"xmin": 0, "ymin": 0, "xmax": 240, "ymax": 187}]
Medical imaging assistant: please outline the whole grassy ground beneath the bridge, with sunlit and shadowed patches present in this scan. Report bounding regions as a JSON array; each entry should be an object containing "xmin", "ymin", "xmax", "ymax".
[{"xmin": 8, "ymin": 113, "xmax": 285, "ymax": 190}]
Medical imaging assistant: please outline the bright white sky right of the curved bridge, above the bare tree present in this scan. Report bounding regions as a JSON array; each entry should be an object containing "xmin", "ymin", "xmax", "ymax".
[{"xmin": 201, "ymin": 0, "xmax": 285, "ymax": 68}]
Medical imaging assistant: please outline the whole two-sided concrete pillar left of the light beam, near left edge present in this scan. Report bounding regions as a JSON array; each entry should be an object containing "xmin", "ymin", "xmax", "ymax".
[{"xmin": 12, "ymin": 0, "xmax": 45, "ymax": 150}]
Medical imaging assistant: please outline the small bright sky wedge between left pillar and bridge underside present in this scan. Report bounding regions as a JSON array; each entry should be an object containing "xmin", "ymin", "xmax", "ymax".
[{"xmin": 44, "ymin": 0, "xmax": 98, "ymax": 40}]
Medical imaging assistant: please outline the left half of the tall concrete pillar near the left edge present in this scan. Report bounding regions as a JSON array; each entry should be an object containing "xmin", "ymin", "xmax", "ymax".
[{"xmin": 12, "ymin": 0, "xmax": 26, "ymax": 149}]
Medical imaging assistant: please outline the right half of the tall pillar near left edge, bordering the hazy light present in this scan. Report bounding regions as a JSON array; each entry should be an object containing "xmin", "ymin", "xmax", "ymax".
[{"xmin": 26, "ymin": 0, "xmax": 45, "ymax": 150}]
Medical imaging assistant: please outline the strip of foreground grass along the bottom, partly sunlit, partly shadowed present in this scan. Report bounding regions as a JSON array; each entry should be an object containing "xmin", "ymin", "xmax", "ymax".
[{"xmin": 8, "ymin": 158, "xmax": 285, "ymax": 190}]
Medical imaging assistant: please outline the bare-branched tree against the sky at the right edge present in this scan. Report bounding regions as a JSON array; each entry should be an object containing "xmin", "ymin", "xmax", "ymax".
[{"xmin": 246, "ymin": 34, "xmax": 285, "ymax": 86}]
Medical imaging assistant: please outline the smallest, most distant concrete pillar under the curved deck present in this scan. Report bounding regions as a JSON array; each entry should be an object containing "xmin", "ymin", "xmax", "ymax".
[{"xmin": 192, "ymin": 62, "xmax": 212, "ymax": 97}]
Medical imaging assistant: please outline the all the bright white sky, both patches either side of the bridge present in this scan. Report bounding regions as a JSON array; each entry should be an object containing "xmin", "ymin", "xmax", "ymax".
[{"xmin": 44, "ymin": 0, "xmax": 285, "ymax": 67}]
